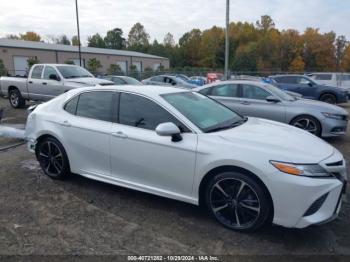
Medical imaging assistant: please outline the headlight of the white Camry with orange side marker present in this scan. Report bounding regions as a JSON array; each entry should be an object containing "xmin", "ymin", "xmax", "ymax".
[{"xmin": 270, "ymin": 161, "xmax": 332, "ymax": 177}]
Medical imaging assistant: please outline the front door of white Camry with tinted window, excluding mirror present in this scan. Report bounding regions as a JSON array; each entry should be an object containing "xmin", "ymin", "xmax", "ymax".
[{"xmin": 111, "ymin": 93, "xmax": 197, "ymax": 199}]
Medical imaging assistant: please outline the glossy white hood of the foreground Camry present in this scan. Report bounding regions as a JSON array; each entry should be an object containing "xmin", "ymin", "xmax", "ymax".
[{"xmin": 213, "ymin": 117, "xmax": 334, "ymax": 164}]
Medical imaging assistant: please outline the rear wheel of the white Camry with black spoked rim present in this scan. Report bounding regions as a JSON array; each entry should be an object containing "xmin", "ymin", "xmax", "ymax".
[{"xmin": 35, "ymin": 137, "xmax": 70, "ymax": 179}]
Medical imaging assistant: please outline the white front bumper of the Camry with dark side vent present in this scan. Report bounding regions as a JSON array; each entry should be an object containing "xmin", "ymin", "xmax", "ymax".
[{"xmin": 270, "ymin": 151, "xmax": 347, "ymax": 228}]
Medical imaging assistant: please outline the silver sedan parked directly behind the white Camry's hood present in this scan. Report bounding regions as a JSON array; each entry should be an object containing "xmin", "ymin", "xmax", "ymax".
[{"xmin": 195, "ymin": 80, "xmax": 348, "ymax": 137}]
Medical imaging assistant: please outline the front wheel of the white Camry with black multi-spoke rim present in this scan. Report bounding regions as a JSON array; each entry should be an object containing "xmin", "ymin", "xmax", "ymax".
[{"xmin": 205, "ymin": 172, "xmax": 272, "ymax": 232}]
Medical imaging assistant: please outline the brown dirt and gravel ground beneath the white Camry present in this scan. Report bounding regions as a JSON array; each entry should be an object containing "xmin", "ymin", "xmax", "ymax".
[{"xmin": 0, "ymin": 98, "xmax": 350, "ymax": 261}]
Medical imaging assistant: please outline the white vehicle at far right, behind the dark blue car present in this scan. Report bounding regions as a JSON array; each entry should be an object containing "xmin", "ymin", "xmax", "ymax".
[{"xmin": 308, "ymin": 73, "xmax": 350, "ymax": 96}]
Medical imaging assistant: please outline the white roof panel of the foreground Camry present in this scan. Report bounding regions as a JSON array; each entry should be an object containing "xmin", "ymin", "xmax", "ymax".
[{"xmin": 69, "ymin": 85, "xmax": 186, "ymax": 97}]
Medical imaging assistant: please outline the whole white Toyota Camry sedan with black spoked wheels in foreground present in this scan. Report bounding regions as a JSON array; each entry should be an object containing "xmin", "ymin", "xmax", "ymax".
[{"xmin": 26, "ymin": 86, "xmax": 346, "ymax": 231}]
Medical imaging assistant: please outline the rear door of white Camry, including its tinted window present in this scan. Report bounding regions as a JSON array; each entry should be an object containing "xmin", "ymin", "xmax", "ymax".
[{"xmin": 59, "ymin": 91, "xmax": 115, "ymax": 178}]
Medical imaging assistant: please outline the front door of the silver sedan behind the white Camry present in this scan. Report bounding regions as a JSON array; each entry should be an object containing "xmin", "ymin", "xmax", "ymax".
[{"xmin": 240, "ymin": 84, "xmax": 286, "ymax": 122}]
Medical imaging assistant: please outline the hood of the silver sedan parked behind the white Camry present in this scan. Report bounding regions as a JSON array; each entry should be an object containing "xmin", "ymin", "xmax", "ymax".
[{"xmin": 289, "ymin": 98, "xmax": 348, "ymax": 115}]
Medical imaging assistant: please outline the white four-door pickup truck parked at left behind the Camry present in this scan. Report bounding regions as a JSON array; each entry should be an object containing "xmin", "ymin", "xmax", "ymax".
[{"xmin": 0, "ymin": 64, "xmax": 114, "ymax": 108}]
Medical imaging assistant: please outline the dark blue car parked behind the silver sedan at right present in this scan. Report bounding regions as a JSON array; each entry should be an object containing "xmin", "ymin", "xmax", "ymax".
[{"xmin": 269, "ymin": 75, "xmax": 348, "ymax": 104}]
